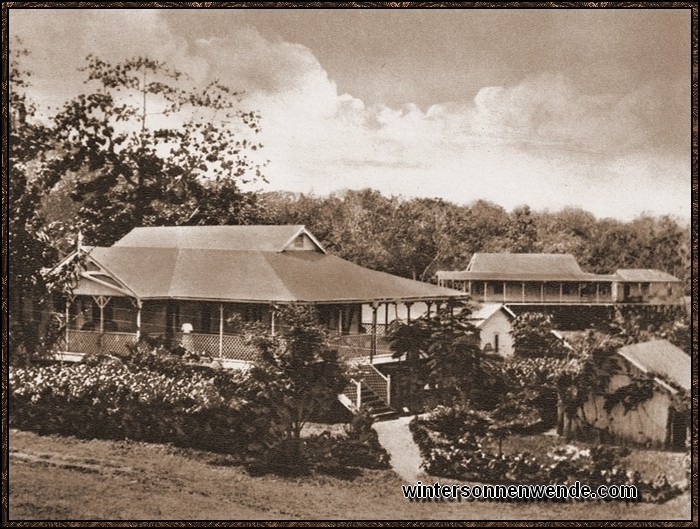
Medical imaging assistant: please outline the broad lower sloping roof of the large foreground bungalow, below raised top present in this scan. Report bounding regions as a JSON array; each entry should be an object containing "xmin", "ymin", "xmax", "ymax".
[{"xmin": 75, "ymin": 245, "xmax": 466, "ymax": 303}]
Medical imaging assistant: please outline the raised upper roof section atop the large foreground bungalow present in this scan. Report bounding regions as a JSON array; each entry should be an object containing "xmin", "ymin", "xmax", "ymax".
[{"xmin": 114, "ymin": 225, "xmax": 322, "ymax": 252}]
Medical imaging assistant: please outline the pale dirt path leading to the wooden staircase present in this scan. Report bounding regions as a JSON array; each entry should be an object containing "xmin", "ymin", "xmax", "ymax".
[{"xmin": 372, "ymin": 417, "xmax": 425, "ymax": 484}]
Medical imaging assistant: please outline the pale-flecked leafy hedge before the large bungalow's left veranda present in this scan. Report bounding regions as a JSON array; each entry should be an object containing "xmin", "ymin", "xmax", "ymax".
[{"xmin": 9, "ymin": 360, "xmax": 256, "ymax": 452}]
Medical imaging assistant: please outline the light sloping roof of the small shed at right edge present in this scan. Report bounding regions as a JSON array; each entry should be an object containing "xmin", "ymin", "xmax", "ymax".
[{"xmin": 618, "ymin": 340, "xmax": 692, "ymax": 391}]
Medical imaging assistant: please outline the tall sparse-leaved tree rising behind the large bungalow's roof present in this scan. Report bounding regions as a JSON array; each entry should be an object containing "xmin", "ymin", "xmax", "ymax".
[{"xmin": 54, "ymin": 56, "xmax": 264, "ymax": 245}]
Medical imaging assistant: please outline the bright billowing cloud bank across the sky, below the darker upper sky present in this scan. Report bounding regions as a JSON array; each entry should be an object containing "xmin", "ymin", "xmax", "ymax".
[{"xmin": 12, "ymin": 10, "xmax": 690, "ymax": 221}]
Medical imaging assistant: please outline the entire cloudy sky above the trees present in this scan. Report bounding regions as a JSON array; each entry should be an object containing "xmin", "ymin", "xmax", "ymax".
[{"xmin": 9, "ymin": 8, "xmax": 691, "ymax": 221}]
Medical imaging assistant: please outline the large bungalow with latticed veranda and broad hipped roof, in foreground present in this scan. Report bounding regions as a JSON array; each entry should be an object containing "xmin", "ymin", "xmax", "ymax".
[{"xmin": 59, "ymin": 226, "xmax": 468, "ymax": 362}]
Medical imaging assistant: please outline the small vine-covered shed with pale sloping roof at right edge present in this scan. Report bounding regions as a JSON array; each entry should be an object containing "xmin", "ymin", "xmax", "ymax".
[{"xmin": 557, "ymin": 340, "xmax": 691, "ymax": 450}]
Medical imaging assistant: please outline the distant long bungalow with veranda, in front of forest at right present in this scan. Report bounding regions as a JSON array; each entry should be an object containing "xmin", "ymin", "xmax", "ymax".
[{"xmin": 437, "ymin": 253, "xmax": 682, "ymax": 305}]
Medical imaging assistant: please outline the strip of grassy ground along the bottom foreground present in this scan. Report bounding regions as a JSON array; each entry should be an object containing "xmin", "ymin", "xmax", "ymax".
[{"xmin": 9, "ymin": 430, "xmax": 691, "ymax": 520}]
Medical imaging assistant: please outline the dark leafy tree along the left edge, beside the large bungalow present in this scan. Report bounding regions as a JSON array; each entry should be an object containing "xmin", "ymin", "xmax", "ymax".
[{"xmin": 8, "ymin": 41, "xmax": 72, "ymax": 361}]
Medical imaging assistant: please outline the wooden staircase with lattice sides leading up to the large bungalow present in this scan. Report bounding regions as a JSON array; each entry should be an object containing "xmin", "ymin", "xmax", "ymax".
[{"xmin": 338, "ymin": 364, "xmax": 399, "ymax": 421}]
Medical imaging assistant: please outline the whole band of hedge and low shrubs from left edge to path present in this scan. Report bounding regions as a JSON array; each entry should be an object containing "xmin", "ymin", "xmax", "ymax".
[{"xmin": 9, "ymin": 342, "xmax": 389, "ymax": 478}]
